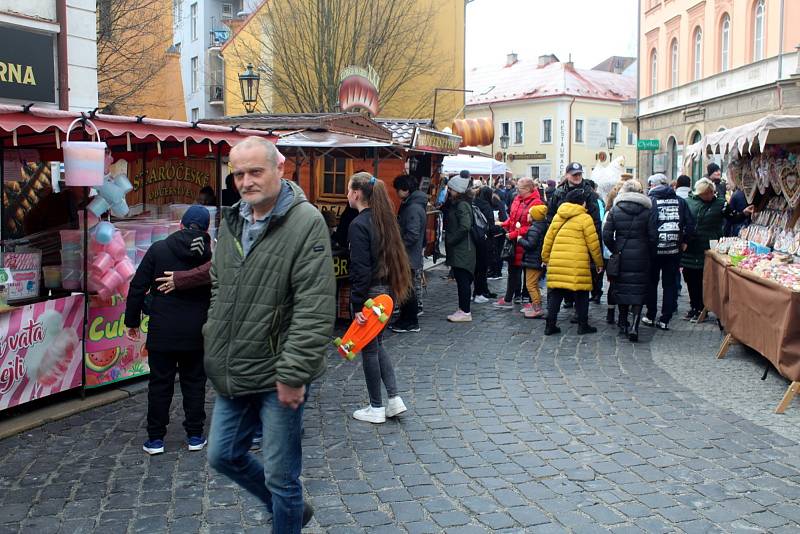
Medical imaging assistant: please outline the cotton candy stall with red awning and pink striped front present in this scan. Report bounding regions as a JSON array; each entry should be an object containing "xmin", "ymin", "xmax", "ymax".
[{"xmin": 0, "ymin": 105, "xmax": 274, "ymax": 409}]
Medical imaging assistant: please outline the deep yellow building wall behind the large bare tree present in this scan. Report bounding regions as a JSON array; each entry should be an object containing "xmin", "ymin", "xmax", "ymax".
[{"xmin": 220, "ymin": 0, "xmax": 465, "ymax": 122}]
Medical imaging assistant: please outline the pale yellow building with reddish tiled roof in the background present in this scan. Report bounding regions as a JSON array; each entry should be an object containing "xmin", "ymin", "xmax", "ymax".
[{"xmin": 466, "ymin": 54, "xmax": 636, "ymax": 181}]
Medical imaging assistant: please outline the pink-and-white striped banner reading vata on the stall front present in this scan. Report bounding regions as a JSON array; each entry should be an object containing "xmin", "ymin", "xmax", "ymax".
[{"xmin": 0, "ymin": 295, "xmax": 83, "ymax": 410}]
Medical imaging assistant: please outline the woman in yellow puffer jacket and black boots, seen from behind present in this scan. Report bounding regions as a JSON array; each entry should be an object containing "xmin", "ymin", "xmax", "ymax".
[{"xmin": 542, "ymin": 189, "xmax": 603, "ymax": 336}]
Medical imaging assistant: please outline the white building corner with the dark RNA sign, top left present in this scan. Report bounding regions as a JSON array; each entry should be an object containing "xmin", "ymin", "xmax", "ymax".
[{"xmin": 0, "ymin": 0, "xmax": 97, "ymax": 111}]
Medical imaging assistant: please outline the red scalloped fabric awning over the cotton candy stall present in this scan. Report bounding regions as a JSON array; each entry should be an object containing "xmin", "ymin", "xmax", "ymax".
[{"xmin": 0, "ymin": 104, "xmax": 274, "ymax": 152}]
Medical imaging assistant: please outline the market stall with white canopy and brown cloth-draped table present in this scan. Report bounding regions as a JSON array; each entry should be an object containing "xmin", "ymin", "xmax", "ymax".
[{"xmin": 686, "ymin": 116, "xmax": 800, "ymax": 413}]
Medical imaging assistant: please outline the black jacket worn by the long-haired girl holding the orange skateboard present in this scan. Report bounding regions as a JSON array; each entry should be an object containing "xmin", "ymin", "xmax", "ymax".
[{"xmin": 347, "ymin": 208, "xmax": 385, "ymax": 311}]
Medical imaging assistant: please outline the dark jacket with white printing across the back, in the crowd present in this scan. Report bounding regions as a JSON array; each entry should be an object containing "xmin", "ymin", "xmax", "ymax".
[{"xmin": 648, "ymin": 185, "xmax": 694, "ymax": 256}]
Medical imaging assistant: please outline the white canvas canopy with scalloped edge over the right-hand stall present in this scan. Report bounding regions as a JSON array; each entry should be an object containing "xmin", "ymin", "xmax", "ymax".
[{"xmin": 686, "ymin": 115, "xmax": 800, "ymax": 160}]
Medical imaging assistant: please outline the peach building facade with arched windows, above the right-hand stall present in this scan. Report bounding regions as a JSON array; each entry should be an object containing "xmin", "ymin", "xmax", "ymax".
[{"xmin": 636, "ymin": 0, "xmax": 800, "ymax": 180}]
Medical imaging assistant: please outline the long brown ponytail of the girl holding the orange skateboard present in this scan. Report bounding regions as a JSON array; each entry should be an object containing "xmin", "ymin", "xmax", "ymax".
[{"xmin": 350, "ymin": 172, "xmax": 411, "ymax": 303}]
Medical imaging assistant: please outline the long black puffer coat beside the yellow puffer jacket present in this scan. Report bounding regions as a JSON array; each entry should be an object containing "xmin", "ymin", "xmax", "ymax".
[{"xmin": 603, "ymin": 192, "xmax": 658, "ymax": 305}]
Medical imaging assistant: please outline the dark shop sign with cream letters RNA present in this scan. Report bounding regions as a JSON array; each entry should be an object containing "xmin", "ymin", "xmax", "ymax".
[{"xmin": 0, "ymin": 26, "xmax": 56, "ymax": 104}]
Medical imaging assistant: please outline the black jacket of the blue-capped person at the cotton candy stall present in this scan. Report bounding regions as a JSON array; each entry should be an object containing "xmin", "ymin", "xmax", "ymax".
[{"xmin": 125, "ymin": 229, "xmax": 211, "ymax": 352}]
